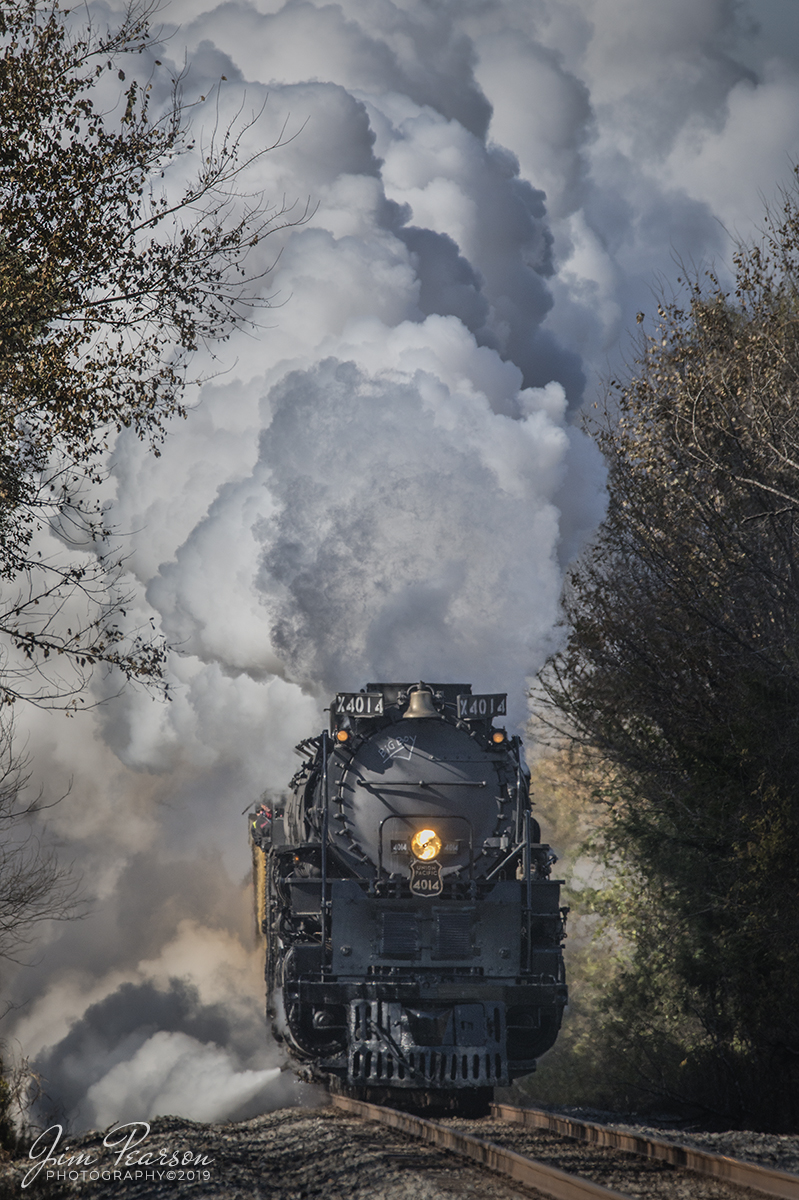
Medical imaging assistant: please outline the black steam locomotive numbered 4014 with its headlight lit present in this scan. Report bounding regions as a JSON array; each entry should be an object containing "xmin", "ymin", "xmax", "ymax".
[{"xmin": 250, "ymin": 683, "xmax": 567, "ymax": 1111}]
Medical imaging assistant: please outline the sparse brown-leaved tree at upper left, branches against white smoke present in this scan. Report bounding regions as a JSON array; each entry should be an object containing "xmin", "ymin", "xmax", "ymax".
[{"xmin": 0, "ymin": 0, "xmax": 302, "ymax": 707}]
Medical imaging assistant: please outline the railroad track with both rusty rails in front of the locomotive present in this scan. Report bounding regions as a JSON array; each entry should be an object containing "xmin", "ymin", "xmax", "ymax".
[{"xmin": 331, "ymin": 1096, "xmax": 799, "ymax": 1200}]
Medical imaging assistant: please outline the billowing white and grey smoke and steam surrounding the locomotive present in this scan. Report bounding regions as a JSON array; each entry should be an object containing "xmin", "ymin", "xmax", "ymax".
[{"xmin": 5, "ymin": 0, "xmax": 799, "ymax": 1129}]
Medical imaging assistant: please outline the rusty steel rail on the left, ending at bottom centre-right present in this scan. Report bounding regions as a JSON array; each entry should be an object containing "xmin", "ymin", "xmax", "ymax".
[{"xmin": 330, "ymin": 1096, "xmax": 630, "ymax": 1200}]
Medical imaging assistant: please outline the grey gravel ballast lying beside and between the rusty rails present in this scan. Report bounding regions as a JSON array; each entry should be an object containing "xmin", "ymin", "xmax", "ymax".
[{"xmin": 6, "ymin": 1108, "xmax": 799, "ymax": 1200}]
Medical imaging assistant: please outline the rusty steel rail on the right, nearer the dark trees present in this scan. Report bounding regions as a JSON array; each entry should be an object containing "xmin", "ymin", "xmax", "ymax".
[{"xmin": 491, "ymin": 1104, "xmax": 799, "ymax": 1200}]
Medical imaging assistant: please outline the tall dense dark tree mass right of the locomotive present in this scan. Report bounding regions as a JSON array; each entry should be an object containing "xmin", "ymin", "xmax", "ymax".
[{"xmin": 542, "ymin": 175, "xmax": 799, "ymax": 1128}]
